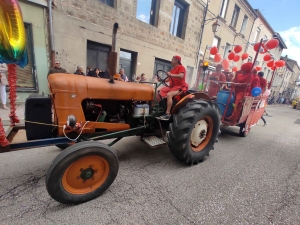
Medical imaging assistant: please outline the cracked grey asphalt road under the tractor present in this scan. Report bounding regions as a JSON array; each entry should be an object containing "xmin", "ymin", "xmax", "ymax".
[{"xmin": 0, "ymin": 106, "xmax": 300, "ymax": 225}]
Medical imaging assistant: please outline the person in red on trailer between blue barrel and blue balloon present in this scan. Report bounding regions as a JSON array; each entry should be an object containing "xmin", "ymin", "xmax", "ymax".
[{"xmin": 227, "ymin": 62, "xmax": 253, "ymax": 120}]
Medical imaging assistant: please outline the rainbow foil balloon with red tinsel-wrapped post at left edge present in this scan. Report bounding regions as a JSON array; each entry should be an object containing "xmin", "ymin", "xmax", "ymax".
[{"xmin": 0, "ymin": 0, "xmax": 28, "ymax": 146}]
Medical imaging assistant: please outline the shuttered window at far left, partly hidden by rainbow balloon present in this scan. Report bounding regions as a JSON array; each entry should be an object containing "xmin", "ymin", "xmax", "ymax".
[{"xmin": 17, "ymin": 23, "xmax": 38, "ymax": 91}]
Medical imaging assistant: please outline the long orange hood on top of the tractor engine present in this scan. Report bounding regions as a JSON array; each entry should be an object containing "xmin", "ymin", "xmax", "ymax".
[{"xmin": 48, "ymin": 73, "xmax": 154, "ymax": 101}]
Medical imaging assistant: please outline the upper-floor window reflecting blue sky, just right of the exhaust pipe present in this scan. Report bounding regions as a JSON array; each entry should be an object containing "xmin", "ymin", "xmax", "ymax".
[{"xmin": 136, "ymin": 0, "xmax": 160, "ymax": 26}]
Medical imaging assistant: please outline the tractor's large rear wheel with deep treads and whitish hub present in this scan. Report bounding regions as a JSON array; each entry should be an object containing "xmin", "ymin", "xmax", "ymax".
[{"xmin": 167, "ymin": 100, "xmax": 220, "ymax": 165}]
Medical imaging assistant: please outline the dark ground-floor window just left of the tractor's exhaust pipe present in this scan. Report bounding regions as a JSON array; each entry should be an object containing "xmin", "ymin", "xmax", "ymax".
[{"xmin": 86, "ymin": 41, "xmax": 110, "ymax": 70}]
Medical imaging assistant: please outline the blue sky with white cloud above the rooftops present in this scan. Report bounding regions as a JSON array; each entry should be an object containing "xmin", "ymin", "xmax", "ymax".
[{"xmin": 248, "ymin": 0, "xmax": 300, "ymax": 65}]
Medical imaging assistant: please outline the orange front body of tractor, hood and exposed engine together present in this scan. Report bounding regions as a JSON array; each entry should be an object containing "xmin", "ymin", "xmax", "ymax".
[{"xmin": 48, "ymin": 73, "xmax": 154, "ymax": 136}]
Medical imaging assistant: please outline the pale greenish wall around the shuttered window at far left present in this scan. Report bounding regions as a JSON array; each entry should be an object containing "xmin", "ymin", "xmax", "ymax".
[{"xmin": 16, "ymin": 0, "xmax": 49, "ymax": 103}]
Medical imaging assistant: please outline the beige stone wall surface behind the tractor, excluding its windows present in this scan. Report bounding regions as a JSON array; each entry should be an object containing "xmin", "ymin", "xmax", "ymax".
[{"xmin": 53, "ymin": 0, "xmax": 203, "ymax": 86}]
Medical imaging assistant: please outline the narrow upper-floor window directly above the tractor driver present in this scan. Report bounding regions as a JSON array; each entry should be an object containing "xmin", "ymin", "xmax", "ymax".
[{"xmin": 170, "ymin": 0, "xmax": 187, "ymax": 38}]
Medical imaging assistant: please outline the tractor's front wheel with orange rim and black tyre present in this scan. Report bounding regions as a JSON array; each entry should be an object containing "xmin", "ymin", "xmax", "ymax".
[{"xmin": 46, "ymin": 141, "xmax": 119, "ymax": 204}]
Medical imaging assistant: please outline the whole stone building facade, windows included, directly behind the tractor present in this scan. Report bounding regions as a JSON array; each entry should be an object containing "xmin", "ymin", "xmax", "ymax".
[{"xmin": 53, "ymin": 0, "xmax": 205, "ymax": 84}]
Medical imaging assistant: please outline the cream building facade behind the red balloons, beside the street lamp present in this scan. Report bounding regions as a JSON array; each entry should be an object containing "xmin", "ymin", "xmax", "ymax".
[{"xmin": 201, "ymin": 0, "xmax": 257, "ymax": 67}]
